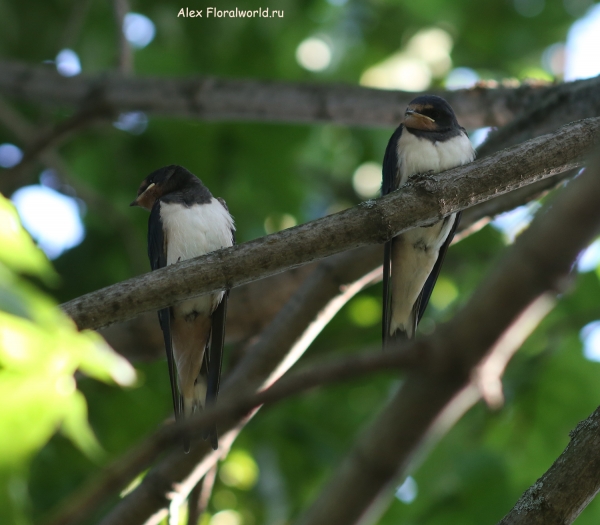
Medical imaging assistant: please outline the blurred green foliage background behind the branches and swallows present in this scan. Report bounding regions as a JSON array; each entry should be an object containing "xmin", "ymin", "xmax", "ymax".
[{"xmin": 0, "ymin": 0, "xmax": 600, "ymax": 525}]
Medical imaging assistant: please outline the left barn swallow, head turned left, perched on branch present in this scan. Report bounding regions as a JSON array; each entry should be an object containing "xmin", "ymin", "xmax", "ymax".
[{"xmin": 131, "ymin": 166, "xmax": 235, "ymax": 452}]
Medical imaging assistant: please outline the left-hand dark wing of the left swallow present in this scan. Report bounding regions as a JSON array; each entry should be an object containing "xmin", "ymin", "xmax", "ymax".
[{"xmin": 148, "ymin": 200, "xmax": 183, "ymax": 419}]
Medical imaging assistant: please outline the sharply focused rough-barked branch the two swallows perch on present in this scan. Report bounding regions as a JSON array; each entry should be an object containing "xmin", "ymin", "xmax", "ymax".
[{"xmin": 62, "ymin": 118, "xmax": 600, "ymax": 328}]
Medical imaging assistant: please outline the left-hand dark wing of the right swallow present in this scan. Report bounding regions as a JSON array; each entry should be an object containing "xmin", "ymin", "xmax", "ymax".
[{"xmin": 381, "ymin": 124, "xmax": 404, "ymax": 346}]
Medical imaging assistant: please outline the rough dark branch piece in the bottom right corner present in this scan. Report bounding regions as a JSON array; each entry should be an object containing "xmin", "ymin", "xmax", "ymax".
[{"xmin": 498, "ymin": 404, "xmax": 600, "ymax": 525}]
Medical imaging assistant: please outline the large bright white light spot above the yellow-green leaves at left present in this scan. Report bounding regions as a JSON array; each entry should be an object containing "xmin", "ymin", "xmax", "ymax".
[{"xmin": 11, "ymin": 185, "xmax": 85, "ymax": 259}]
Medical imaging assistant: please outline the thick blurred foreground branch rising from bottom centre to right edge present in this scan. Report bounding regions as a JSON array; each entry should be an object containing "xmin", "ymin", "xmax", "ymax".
[{"xmin": 298, "ymin": 151, "xmax": 600, "ymax": 525}]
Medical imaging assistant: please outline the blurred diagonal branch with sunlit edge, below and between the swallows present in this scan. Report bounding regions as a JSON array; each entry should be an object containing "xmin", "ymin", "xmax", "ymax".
[{"xmin": 52, "ymin": 248, "xmax": 382, "ymax": 525}]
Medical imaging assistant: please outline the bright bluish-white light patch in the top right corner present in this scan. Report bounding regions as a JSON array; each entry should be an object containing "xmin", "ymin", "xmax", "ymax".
[{"xmin": 565, "ymin": 5, "xmax": 600, "ymax": 80}]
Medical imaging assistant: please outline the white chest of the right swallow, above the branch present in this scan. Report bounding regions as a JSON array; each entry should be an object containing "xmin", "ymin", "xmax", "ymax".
[{"xmin": 397, "ymin": 129, "xmax": 475, "ymax": 186}]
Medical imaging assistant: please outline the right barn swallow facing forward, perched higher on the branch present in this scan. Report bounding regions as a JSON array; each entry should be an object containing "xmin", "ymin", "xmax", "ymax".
[{"xmin": 381, "ymin": 95, "xmax": 475, "ymax": 347}]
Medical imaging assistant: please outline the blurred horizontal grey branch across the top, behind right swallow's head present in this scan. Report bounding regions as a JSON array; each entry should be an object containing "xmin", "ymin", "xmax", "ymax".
[{"xmin": 0, "ymin": 62, "xmax": 588, "ymax": 128}]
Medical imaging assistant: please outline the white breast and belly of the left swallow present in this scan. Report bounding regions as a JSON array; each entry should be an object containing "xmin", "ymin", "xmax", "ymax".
[{"xmin": 160, "ymin": 198, "xmax": 235, "ymax": 315}]
